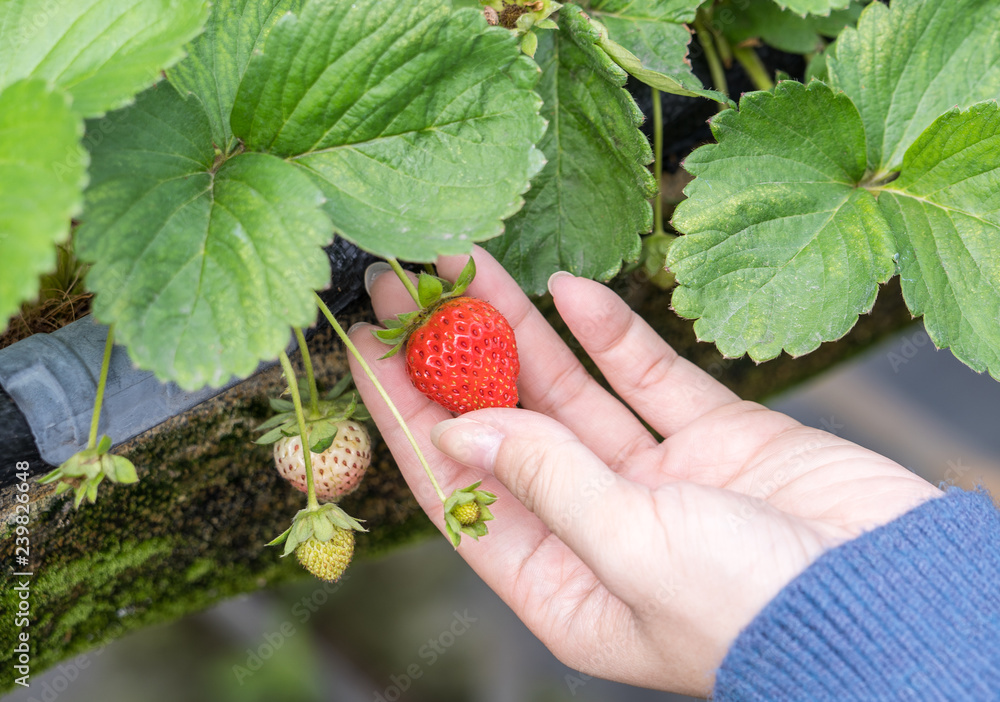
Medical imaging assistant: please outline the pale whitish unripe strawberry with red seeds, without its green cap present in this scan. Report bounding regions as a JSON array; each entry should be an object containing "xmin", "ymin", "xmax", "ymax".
[{"xmin": 274, "ymin": 419, "xmax": 372, "ymax": 501}]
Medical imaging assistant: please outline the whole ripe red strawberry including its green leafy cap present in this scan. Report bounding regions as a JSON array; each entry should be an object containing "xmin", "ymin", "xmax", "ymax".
[{"xmin": 375, "ymin": 258, "xmax": 521, "ymax": 413}]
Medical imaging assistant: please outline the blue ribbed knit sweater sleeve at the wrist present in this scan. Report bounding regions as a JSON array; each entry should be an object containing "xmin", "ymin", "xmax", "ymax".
[{"xmin": 714, "ymin": 489, "xmax": 1000, "ymax": 702}]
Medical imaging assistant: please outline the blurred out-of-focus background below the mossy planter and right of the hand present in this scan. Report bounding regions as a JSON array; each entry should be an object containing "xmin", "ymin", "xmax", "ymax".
[{"xmin": 3, "ymin": 324, "xmax": 1000, "ymax": 702}]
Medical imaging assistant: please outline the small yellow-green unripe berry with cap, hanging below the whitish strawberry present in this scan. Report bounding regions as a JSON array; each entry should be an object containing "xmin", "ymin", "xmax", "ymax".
[{"xmin": 268, "ymin": 504, "xmax": 367, "ymax": 582}]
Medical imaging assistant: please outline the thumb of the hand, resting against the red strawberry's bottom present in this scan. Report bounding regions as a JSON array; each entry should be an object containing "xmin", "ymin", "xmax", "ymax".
[{"xmin": 431, "ymin": 409, "xmax": 656, "ymax": 603}]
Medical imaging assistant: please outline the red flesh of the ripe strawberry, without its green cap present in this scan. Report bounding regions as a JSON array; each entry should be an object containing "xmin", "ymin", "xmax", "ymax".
[{"xmin": 406, "ymin": 297, "xmax": 521, "ymax": 413}]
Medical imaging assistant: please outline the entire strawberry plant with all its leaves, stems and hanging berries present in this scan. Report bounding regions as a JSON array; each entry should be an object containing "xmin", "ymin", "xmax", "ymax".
[{"xmin": 0, "ymin": 0, "xmax": 1000, "ymax": 574}]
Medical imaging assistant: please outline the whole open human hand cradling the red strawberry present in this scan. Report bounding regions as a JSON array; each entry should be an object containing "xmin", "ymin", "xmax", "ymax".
[{"xmin": 351, "ymin": 249, "xmax": 942, "ymax": 695}]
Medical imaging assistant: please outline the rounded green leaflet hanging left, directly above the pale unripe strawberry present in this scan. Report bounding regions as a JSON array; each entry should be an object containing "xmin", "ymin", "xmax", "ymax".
[{"xmin": 77, "ymin": 83, "xmax": 330, "ymax": 390}]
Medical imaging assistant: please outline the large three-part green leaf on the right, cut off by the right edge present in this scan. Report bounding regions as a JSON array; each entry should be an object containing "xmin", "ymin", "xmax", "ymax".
[{"xmin": 668, "ymin": 0, "xmax": 1000, "ymax": 374}]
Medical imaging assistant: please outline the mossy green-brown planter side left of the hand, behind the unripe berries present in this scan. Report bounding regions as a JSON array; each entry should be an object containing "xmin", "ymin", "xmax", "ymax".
[{"xmin": 0, "ymin": 312, "xmax": 433, "ymax": 688}]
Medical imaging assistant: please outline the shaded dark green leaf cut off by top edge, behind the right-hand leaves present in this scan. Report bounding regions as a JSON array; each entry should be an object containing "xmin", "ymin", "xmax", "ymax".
[{"xmin": 715, "ymin": 0, "xmax": 865, "ymax": 55}]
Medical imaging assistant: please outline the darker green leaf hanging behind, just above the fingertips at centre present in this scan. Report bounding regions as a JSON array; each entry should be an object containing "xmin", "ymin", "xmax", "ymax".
[{"xmin": 487, "ymin": 5, "xmax": 656, "ymax": 293}]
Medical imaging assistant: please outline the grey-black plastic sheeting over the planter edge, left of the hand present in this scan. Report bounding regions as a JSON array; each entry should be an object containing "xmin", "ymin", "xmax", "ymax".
[{"xmin": 0, "ymin": 238, "xmax": 377, "ymax": 489}]
